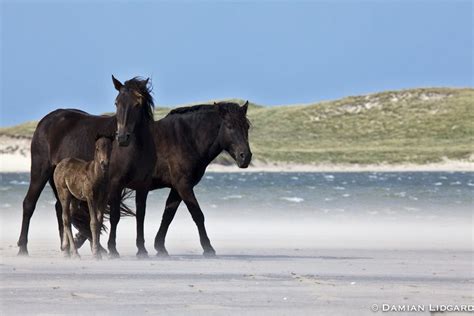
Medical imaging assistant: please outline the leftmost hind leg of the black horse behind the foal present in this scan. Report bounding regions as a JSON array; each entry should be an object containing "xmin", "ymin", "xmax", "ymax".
[{"xmin": 18, "ymin": 161, "xmax": 52, "ymax": 255}]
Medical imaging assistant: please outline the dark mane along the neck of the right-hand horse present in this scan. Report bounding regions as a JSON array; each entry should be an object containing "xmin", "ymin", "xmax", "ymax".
[{"xmin": 166, "ymin": 101, "xmax": 250, "ymax": 126}]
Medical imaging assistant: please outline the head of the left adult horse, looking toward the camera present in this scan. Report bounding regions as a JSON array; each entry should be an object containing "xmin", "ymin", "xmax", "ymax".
[{"xmin": 112, "ymin": 76, "xmax": 153, "ymax": 146}]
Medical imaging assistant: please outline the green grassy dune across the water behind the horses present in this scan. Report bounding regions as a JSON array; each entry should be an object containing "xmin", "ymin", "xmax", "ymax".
[{"xmin": 0, "ymin": 88, "xmax": 474, "ymax": 164}]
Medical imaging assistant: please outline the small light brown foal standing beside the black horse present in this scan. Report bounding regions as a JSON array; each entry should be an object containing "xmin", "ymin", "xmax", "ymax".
[{"xmin": 54, "ymin": 136, "xmax": 113, "ymax": 259}]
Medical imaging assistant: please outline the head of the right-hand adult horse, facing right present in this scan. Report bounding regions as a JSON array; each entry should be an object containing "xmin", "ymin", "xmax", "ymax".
[{"xmin": 216, "ymin": 101, "xmax": 252, "ymax": 168}]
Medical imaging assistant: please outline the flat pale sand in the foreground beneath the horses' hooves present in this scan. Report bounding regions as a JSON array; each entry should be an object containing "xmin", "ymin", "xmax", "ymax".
[{"xmin": 1, "ymin": 245, "xmax": 474, "ymax": 315}]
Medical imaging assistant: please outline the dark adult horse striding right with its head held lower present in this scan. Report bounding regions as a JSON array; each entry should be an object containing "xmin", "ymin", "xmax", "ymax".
[{"xmin": 77, "ymin": 102, "xmax": 252, "ymax": 256}]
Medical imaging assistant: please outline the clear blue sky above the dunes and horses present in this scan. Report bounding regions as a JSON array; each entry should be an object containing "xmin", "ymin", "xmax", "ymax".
[{"xmin": 0, "ymin": 0, "xmax": 473, "ymax": 126}]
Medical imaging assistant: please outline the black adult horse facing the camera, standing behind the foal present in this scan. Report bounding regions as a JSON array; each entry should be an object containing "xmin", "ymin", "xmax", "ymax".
[{"xmin": 18, "ymin": 76, "xmax": 156, "ymax": 257}]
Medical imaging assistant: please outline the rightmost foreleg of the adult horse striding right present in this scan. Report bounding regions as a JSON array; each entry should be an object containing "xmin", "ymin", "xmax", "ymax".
[{"xmin": 177, "ymin": 183, "xmax": 216, "ymax": 257}]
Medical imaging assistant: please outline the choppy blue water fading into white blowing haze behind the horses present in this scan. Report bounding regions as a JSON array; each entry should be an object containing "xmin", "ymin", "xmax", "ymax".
[{"xmin": 0, "ymin": 172, "xmax": 474, "ymax": 250}]
